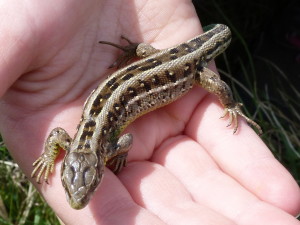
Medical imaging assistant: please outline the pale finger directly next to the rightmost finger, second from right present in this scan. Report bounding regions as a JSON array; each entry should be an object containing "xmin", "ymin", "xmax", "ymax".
[{"xmin": 153, "ymin": 137, "xmax": 296, "ymax": 225}]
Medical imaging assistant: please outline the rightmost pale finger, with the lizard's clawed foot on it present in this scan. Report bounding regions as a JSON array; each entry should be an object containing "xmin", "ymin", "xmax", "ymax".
[{"xmin": 186, "ymin": 96, "xmax": 300, "ymax": 215}]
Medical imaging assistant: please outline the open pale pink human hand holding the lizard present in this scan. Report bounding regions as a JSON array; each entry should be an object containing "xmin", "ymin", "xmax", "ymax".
[{"xmin": 0, "ymin": 0, "xmax": 300, "ymax": 225}]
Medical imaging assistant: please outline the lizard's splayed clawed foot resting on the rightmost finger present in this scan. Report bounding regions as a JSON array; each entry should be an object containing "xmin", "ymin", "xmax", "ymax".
[{"xmin": 220, "ymin": 103, "xmax": 262, "ymax": 135}]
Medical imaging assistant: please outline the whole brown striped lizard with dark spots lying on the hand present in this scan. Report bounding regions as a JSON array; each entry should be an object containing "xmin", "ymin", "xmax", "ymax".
[{"xmin": 32, "ymin": 24, "xmax": 262, "ymax": 209}]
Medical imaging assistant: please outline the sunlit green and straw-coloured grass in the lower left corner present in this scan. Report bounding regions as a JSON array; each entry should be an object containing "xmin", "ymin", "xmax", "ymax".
[{"xmin": 0, "ymin": 139, "xmax": 59, "ymax": 225}]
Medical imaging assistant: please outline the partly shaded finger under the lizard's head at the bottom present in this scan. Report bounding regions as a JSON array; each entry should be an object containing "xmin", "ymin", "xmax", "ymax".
[{"xmin": 43, "ymin": 169, "xmax": 165, "ymax": 225}]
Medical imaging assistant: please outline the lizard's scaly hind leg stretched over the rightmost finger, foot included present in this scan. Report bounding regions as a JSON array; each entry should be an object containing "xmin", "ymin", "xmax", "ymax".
[{"xmin": 195, "ymin": 67, "xmax": 262, "ymax": 135}]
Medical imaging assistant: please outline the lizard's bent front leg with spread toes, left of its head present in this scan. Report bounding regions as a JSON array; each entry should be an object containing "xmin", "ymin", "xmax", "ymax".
[{"xmin": 31, "ymin": 127, "xmax": 72, "ymax": 183}]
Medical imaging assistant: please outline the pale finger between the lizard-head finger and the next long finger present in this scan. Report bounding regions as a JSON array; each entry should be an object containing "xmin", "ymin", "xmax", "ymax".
[{"xmin": 120, "ymin": 162, "xmax": 235, "ymax": 225}]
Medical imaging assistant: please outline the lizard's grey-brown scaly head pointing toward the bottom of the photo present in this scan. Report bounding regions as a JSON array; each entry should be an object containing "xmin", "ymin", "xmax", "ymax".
[{"xmin": 61, "ymin": 152, "xmax": 104, "ymax": 209}]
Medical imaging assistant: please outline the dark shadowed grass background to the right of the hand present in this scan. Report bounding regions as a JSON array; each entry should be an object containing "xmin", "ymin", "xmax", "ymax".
[{"xmin": 193, "ymin": 0, "xmax": 300, "ymax": 184}]
